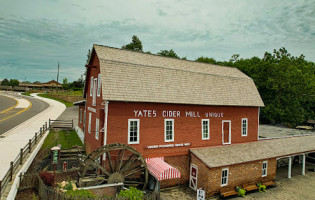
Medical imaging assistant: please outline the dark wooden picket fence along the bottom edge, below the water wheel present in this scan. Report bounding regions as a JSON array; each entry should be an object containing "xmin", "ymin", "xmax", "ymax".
[{"xmin": 19, "ymin": 173, "xmax": 160, "ymax": 200}]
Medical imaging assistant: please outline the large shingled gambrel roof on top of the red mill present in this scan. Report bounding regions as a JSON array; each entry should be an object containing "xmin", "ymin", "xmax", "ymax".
[{"xmin": 93, "ymin": 45, "xmax": 264, "ymax": 106}]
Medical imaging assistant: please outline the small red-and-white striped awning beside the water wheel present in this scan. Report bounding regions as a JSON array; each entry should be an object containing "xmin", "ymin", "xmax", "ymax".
[{"xmin": 147, "ymin": 158, "xmax": 180, "ymax": 181}]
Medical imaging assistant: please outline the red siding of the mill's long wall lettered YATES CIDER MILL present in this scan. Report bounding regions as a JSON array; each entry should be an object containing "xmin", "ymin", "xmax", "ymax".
[{"xmin": 107, "ymin": 102, "xmax": 258, "ymax": 157}]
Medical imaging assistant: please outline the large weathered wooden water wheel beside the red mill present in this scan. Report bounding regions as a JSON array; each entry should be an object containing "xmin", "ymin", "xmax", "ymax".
[{"xmin": 79, "ymin": 143, "xmax": 148, "ymax": 190}]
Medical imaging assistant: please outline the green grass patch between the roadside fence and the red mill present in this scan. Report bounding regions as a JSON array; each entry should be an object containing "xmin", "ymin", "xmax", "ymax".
[{"xmin": 41, "ymin": 130, "xmax": 83, "ymax": 149}]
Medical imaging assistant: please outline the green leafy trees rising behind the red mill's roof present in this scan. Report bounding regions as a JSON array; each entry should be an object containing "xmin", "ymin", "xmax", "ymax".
[{"xmin": 122, "ymin": 35, "xmax": 315, "ymax": 127}]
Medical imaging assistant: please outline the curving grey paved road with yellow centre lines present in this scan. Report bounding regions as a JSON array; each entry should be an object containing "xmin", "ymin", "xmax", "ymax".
[{"xmin": 0, "ymin": 93, "xmax": 48, "ymax": 135}]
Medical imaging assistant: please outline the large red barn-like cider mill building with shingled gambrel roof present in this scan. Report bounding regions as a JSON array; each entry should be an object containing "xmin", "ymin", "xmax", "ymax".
[{"xmin": 79, "ymin": 45, "xmax": 315, "ymax": 195}]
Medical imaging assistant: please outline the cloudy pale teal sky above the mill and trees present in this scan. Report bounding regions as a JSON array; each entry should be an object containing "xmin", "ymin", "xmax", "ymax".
[{"xmin": 0, "ymin": 0, "xmax": 315, "ymax": 82}]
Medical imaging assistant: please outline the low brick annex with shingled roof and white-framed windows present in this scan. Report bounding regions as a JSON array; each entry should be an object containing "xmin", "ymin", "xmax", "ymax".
[{"xmin": 190, "ymin": 135, "xmax": 315, "ymax": 196}]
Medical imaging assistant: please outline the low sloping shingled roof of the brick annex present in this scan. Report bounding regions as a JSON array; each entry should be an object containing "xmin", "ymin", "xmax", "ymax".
[{"xmin": 190, "ymin": 135, "xmax": 315, "ymax": 167}]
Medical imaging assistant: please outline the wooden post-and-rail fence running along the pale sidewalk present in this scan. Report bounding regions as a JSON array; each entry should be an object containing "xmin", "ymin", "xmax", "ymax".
[{"xmin": 0, "ymin": 122, "xmax": 48, "ymax": 198}]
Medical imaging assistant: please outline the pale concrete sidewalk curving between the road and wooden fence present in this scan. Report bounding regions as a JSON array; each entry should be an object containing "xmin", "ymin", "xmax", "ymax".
[{"xmin": 0, "ymin": 94, "xmax": 66, "ymax": 180}]
